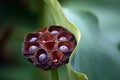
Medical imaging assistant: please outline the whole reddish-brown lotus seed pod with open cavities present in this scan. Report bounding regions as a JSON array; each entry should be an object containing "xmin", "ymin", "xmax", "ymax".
[{"xmin": 22, "ymin": 25, "xmax": 76, "ymax": 70}]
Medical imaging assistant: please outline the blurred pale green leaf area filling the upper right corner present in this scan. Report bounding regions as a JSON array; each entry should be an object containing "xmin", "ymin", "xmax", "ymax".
[{"xmin": 63, "ymin": 0, "xmax": 120, "ymax": 47}]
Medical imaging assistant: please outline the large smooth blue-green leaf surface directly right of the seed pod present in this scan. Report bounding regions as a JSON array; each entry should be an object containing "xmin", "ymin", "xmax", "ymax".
[{"xmin": 64, "ymin": 3, "xmax": 120, "ymax": 80}]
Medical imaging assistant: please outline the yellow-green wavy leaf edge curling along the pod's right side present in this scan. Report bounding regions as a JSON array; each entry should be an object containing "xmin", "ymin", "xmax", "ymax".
[{"xmin": 45, "ymin": 0, "xmax": 87, "ymax": 80}]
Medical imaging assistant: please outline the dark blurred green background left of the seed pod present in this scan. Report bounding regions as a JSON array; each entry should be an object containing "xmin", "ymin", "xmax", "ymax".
[{"xmin": 0, "ymin": 0, "xmax": 66, "ymax": 80}]
